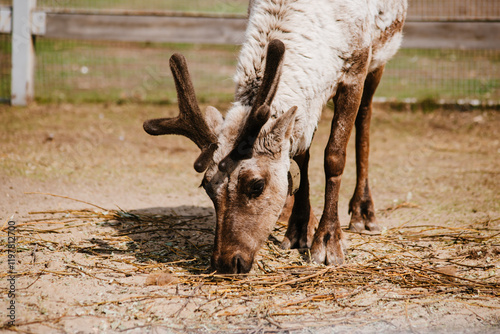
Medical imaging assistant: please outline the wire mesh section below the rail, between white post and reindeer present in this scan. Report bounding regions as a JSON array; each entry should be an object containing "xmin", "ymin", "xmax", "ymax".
[{"xmin": 35, "ymin": 39, "xmax": 238, "ymax": 103}]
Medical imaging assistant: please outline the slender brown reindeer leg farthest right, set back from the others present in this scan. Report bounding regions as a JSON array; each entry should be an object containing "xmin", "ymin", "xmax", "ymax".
[{"xmin": 349, "ymin": 66, "xmax": 384, "ymax": 232}]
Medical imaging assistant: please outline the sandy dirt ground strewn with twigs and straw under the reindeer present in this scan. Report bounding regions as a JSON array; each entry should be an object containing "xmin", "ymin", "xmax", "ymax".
[{"xmin": 0, "ymin": 104, "xmax": 500, "ymax": 333}]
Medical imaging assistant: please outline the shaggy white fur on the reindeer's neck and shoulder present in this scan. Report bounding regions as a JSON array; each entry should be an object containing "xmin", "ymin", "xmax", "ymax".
[{"xmin": 222, "ymin": 0, "xmax": 407, "ymax": 157}]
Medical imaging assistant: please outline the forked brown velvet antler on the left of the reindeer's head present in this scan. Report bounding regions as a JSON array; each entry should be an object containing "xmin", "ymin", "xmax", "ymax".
[{"xmin": 143, "ymin": 53, "xmax": 217, "ymax": 173}]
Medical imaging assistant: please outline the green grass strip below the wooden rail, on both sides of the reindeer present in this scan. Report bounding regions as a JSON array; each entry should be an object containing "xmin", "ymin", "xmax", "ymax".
[{"xmin": 0, "ymin": 35, "xmax": 500, "ymax": 104}]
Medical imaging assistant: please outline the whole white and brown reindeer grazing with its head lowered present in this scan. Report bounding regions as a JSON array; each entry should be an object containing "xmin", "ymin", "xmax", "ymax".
[{"xmin": 144, "ymin": 0, "xmax": 407, "ymax": 274}]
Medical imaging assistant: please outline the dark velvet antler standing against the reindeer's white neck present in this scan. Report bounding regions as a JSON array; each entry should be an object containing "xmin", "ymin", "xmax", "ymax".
[{"xmin": 219, "ymin": 39, "xmax": 285, "ymax": 172}]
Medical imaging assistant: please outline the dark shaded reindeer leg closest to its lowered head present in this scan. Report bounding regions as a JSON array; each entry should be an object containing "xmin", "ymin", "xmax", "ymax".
[{"xmin": 281, "ymin": 150, "xmax": 318, "ymax": 249}]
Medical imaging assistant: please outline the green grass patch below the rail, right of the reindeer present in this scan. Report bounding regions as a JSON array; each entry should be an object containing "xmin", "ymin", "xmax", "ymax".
[{"xmin": 377, "ymin": 49, "xmax": 500, "ymax": 101}]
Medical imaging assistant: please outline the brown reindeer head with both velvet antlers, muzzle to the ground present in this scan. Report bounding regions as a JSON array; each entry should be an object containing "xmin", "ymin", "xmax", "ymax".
[{"xmin": 144, "ymin": 40, "xmax": 298, "ymax": 274}]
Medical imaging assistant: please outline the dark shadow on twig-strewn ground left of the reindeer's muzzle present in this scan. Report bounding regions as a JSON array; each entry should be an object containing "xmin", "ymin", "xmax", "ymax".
[{"xmin": 84, "ymin": 206, "xmax": 215, "ymax": 274}]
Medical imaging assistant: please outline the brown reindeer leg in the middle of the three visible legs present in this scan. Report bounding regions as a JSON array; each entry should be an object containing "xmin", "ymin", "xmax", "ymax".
[{"xmin": 311, "ymin": 80, "xmax": 364, "ymax": 265}]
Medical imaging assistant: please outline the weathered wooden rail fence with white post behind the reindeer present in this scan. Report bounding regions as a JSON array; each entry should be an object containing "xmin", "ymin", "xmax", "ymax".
[{"xmin": 0, "ymin": 0, "xmax": 500, "ymax": 105}]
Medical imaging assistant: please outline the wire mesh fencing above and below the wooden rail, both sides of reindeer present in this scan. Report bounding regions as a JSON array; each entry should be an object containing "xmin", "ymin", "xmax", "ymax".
[{"xmin": 0, "ymin": 0, "xmax": 500, "ymax": 103}]
